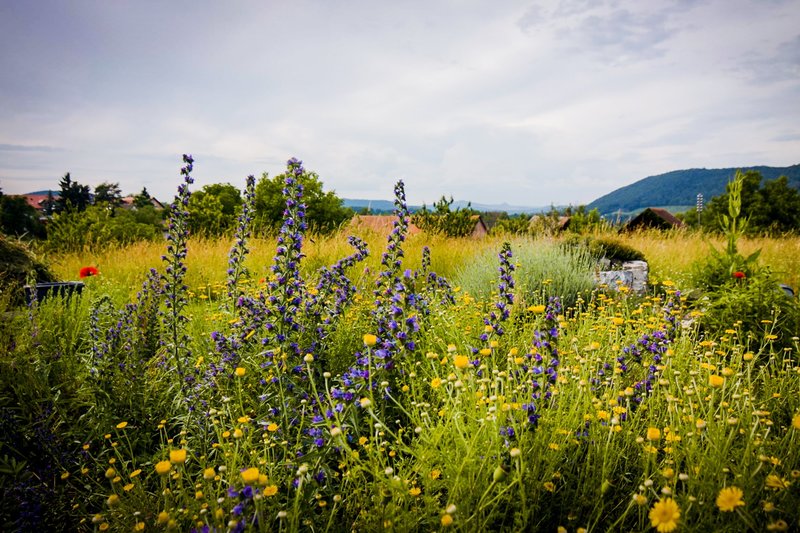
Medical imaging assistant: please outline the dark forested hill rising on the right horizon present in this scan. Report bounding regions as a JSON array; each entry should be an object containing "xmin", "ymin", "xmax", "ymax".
[{"xmin": 586, "ymin": 164, "xmax": 800, "ymax": 217}]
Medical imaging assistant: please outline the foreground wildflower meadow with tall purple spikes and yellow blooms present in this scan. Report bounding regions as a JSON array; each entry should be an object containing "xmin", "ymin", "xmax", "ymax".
[{"xmin": 0, "ymin": 156, "xmax": 800, "ymax": 532}]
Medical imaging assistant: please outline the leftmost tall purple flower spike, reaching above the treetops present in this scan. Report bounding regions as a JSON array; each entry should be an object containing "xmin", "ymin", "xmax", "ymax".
[{"xmin": 161, "ymin": 154, "xmax": 195, "ymax": 409}]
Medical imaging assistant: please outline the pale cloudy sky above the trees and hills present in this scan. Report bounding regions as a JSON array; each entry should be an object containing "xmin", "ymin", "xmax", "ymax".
[{"xmin": 0, "ymin": 0, "xmax": 800, "ymax": 206}]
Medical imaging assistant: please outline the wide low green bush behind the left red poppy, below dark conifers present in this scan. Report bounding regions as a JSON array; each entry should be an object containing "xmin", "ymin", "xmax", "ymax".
[{"xmin": 47, "ymin": 206, "xmax": 163, "ymax": 251}]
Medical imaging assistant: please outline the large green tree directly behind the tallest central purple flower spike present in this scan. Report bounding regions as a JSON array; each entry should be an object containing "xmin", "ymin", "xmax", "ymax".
[{"xmin": 255, "ymin": 167, "xmax": 353, "ymax": 233}]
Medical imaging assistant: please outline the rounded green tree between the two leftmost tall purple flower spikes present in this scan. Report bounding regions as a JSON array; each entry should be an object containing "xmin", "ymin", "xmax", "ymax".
[{"xmin": 188, "ymin": 183, "xmax": 242, "ymax": 236}]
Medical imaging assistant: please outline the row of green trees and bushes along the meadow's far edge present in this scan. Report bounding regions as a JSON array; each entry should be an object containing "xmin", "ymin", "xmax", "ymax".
[{"xmin": 0, "ymin": 170, "xmax": 800, "ymax": 249}]
